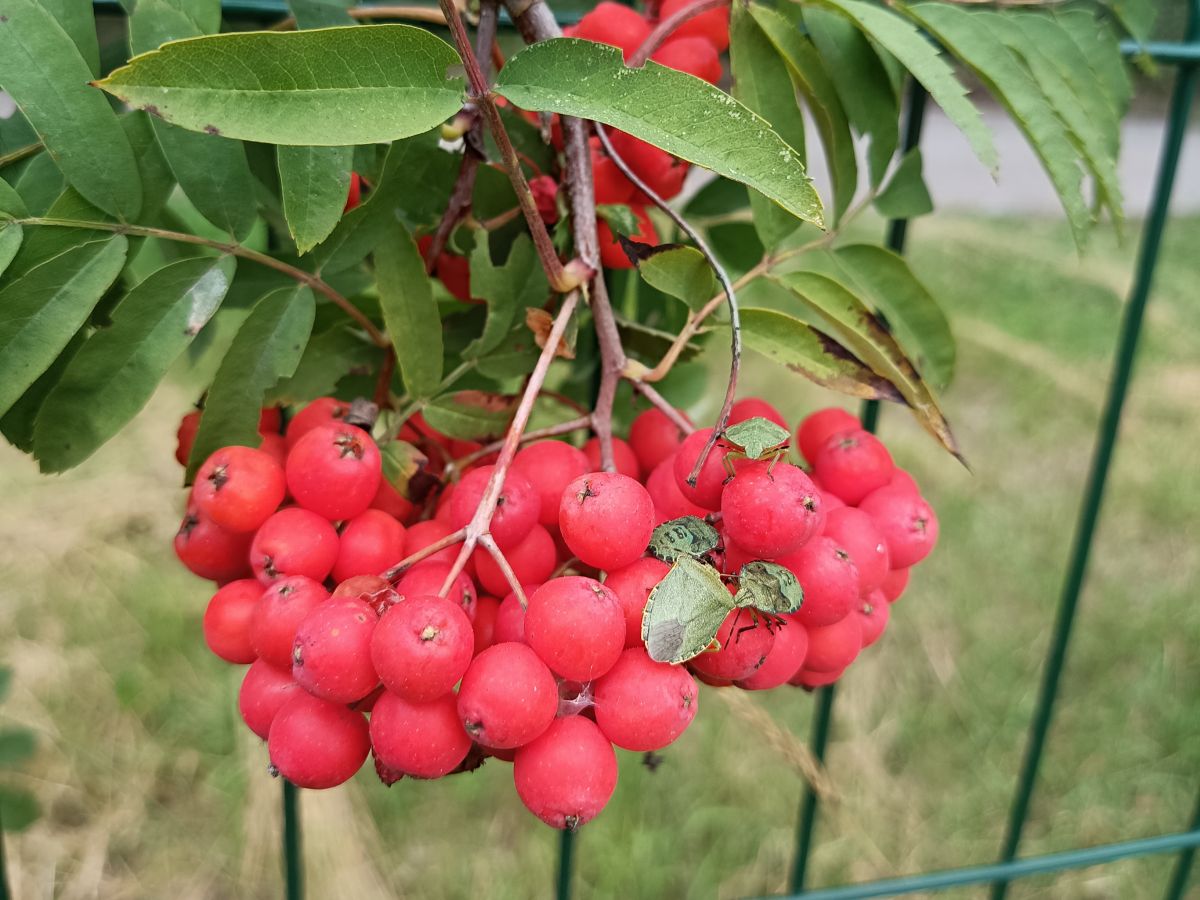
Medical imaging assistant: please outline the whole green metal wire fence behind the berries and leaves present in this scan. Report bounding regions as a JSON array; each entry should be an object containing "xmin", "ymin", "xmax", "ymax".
[{"xmin": 60, "ymin": 0, "xmax": 1200, "ymax": 900}]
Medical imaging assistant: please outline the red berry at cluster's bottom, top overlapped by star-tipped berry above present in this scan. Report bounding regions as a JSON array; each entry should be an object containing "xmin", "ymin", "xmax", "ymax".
[{"xmin": 371, "ymin": 691, "xmax": 470, "ymax": 778}]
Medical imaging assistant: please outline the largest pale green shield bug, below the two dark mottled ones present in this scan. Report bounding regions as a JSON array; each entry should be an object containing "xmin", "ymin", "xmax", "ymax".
[{"xmin": 642, "ymin": 556, "xmax": 733, "ymax": 664}]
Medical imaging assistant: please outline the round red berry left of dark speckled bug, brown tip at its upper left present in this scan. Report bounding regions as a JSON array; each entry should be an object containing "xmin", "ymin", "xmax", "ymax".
[{"xmin": 558, "ymin": 472, "xmax": 654, "ymax": 570}]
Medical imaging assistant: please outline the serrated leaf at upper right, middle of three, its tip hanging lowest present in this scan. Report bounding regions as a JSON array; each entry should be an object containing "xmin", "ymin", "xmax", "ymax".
[{"xmin": 908, "ymin": 2, "xmax": 1092, "ymax": 246}]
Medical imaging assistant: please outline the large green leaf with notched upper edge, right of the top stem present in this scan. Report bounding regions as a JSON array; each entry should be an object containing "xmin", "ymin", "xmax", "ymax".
[{"xmin": 496, "ymin": 38, "xmax": 822, "ymax": 224}]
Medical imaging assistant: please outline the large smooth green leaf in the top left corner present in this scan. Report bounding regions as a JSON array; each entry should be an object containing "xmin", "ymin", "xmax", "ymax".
[{"xmin": 0, "ymin": 0, "xmax": 142, "ymax": 220}]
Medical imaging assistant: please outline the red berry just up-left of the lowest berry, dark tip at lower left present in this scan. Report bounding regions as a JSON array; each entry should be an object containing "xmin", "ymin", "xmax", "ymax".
[{"xmin": 457, "ymin": 643, "xmax": 558, "ymax": 750}]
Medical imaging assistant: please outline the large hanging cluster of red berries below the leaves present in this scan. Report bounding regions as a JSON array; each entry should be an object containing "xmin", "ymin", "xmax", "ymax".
[{"xmin": 175, "ymin": 398, "xmax": 937, "ymax": 828}]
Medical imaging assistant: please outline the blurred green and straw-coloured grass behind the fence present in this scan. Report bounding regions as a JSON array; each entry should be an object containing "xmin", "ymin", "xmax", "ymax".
[{"xmin": 0, "ymin": 217, "xmax": 1200, "ymax": 900}]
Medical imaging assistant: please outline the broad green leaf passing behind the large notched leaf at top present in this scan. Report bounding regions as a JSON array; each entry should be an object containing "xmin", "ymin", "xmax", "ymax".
[{"xmin": 721, "ymin": 4, "xmax": 805, "ymax": 247}]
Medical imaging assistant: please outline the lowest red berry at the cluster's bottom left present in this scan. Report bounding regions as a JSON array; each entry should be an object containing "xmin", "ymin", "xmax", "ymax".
[{"xmin": 266, "ymin": 691, "xmax": 371, "ymax": 790}]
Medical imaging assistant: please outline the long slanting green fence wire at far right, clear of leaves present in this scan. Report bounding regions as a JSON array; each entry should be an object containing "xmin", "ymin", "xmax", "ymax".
[{"xmin": 991, "ymin": 0, "xmax": 1200, "ymax": 900}]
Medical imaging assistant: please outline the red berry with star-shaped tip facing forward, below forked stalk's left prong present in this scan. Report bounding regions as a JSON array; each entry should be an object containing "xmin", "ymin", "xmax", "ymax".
[{"xmin": 371, "ymin": 596, "xmax": 475, "ymax": 705}]
